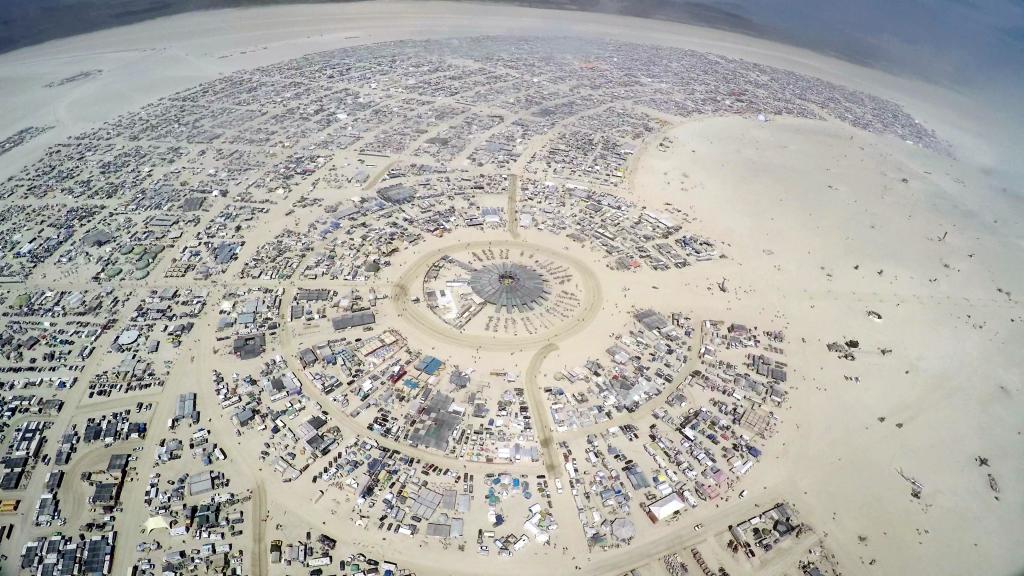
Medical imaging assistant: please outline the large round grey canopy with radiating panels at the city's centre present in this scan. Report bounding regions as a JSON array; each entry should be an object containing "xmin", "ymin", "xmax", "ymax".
[{"xmin": 469, "ymin": 262, "xmax": 548, "ymax": 312}]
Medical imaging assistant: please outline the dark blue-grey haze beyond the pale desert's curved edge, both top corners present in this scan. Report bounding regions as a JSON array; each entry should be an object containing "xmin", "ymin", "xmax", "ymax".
[{"xmin": 6, "ymin": 0, "xmax": 1024, "ymax": 91}]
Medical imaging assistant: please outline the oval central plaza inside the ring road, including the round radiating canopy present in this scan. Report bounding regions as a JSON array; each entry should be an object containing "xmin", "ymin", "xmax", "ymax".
[{"xmin": 394, "ymin": 240, "xmax": 601, "ymax": 340}]
